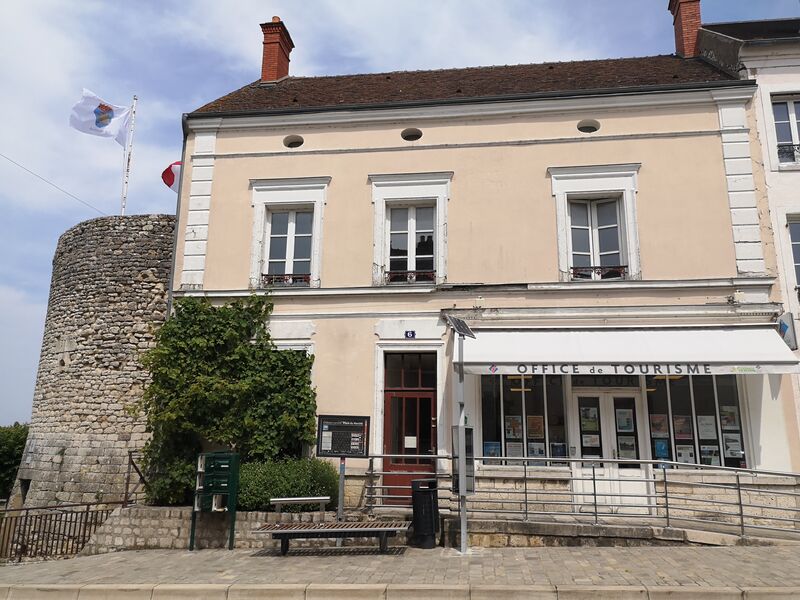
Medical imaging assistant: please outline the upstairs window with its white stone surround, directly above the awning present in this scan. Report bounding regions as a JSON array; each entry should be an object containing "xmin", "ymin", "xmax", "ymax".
[{"xmin": 548, "ymin": 163, "xmax": 641, "ymax": 281}]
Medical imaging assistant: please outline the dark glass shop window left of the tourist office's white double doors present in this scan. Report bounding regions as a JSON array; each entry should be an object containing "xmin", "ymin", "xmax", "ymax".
[{"xmin": 481, "ymin": 375, "xmax": 567, "ymax": 464}]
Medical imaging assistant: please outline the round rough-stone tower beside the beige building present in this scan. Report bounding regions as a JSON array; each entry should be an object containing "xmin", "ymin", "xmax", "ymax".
[{"xmin": 12, "ymin": 215, "xmax": 175, "ymax": 506}]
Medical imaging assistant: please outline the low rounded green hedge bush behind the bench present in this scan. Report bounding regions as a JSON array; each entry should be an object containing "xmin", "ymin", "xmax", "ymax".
[{"xmin": 239, "ymin": 458, "xmax": 339, "ymax": 511}]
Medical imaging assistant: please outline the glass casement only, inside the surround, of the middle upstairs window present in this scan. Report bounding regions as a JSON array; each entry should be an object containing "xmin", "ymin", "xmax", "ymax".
[{"xmin": 386, "ymin": 206, "xmax": 436, "ymax": 283}]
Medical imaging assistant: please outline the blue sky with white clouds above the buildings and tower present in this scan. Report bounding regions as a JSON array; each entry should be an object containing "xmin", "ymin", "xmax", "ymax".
[{"xmin": 0, "ymin": 0, "xmax": 800, "ymax": 425}]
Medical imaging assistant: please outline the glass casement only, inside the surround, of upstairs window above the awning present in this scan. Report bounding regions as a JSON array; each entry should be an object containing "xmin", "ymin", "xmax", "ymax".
[{"xmin": 569, "ymin": 198, "xmax": 627, "ymax": 279}]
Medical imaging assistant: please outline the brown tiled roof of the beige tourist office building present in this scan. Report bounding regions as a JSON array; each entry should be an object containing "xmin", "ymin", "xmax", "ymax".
[{"xmin": 191, "ymin": 55, "xmax": 735, "ymax": 117}]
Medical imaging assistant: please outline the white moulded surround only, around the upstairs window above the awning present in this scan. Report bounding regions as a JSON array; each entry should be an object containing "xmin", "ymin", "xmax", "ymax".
[{"xmin": 547, "ymin": 163, "xmax": 642, "ymax": 283}]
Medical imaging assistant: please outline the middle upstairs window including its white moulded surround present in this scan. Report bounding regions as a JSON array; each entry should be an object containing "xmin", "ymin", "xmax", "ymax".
[{"xmin": 369, "ymin": 172, "xmax": 453, "ymax": 285}]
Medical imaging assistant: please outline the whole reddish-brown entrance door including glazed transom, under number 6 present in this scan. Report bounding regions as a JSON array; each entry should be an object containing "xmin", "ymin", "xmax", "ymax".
[{"xmin": 382, "ymin": 353, "xmax": 437, "ymax": 505}]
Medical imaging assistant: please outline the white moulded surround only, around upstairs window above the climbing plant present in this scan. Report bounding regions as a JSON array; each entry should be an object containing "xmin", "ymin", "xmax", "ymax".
[{"xmin": 250, "ymin": 177, "xmax": 331, "ymax": 289}]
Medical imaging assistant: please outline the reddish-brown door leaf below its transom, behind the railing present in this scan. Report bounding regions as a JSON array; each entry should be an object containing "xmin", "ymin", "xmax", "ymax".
[{"xmin": 383, "ymin": 390, "xmax": 436, "ymax": 505}]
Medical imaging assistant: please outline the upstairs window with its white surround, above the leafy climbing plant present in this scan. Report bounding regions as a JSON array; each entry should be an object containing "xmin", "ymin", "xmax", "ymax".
[{"xmin": 250, "ymin": 177, "xmax": 330, "ymax": 289}]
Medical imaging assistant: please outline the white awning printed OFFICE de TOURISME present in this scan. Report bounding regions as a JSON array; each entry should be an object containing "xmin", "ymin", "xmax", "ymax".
[{"xmin": 464, "ymin": 327, "xmax": 800, "ymax": 375}]
